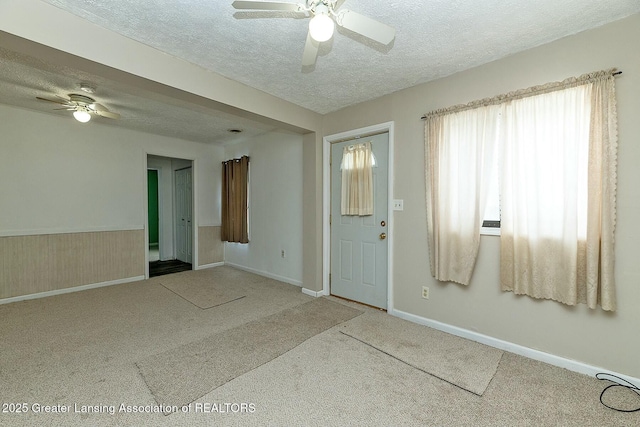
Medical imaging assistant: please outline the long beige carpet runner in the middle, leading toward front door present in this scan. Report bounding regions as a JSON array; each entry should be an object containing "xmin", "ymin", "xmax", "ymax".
[{"xmin": 136, "ymin": 298, "xmax": 362, "ymax": 407}]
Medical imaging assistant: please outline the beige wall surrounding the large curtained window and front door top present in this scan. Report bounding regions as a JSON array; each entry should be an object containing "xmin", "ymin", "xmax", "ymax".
[{"xmin": 323, "ymin": 15, "xmax": 640, "ymax": 377}]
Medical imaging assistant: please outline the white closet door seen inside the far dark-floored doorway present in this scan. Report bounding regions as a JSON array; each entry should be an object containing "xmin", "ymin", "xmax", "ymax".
[{"xmin": 175, "ymin": 168, "xmax": 193, "ymax": 264}]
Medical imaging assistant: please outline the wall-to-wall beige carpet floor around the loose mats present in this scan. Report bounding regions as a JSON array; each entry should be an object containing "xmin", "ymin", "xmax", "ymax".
[{"xmin": 0, "ymin": 267, "xmax": 640, "ymax": 427}]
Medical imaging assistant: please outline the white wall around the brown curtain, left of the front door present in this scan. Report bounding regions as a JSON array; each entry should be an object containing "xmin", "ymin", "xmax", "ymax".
[{"xmin": 225, "ymin": 132, "xmax": 302, "ymax": 285}]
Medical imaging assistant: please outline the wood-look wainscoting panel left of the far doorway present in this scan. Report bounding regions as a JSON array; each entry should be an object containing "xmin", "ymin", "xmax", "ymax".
[{"xmin": 0, "ymin": 230, "xmax": 145, "ymax": 299}]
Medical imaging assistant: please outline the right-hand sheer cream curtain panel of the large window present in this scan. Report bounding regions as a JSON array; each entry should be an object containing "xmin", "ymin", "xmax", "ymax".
[{"xmin": 500, "ymin": 71, "xmax": 617, "ymax": 310}]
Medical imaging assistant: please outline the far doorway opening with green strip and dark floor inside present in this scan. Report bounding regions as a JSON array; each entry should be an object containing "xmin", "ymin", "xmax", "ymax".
[{"xmin": 146, "ymin": 155, "xmax": 194, "ymax": 277}]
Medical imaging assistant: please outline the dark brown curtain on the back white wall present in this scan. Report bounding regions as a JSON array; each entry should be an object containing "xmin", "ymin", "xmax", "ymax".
[{"xmin": 220, "ymin": 156, "xmax": 249, "ymax": 243}]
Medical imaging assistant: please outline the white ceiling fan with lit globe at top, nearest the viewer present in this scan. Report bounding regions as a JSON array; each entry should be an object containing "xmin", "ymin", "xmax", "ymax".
[{"xmin": 232, "ymin": 0, "xmax": 396, "ymax": 67}]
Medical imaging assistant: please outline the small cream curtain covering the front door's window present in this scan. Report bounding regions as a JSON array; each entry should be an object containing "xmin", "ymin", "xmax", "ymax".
[{"xmin": 340, "ymin": 141, "xmax": 373, "ymax": 216}]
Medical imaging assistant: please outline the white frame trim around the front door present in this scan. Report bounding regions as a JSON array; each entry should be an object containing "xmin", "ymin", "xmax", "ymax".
[{"xmin": 322, "ymin": 121, "xmax": 395, "ymax": 312}]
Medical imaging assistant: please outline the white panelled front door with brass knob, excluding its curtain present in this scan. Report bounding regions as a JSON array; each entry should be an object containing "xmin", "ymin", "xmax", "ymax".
[{"xmin": 329, "ymin": 133, "xmax": 389, "ymax": 309}]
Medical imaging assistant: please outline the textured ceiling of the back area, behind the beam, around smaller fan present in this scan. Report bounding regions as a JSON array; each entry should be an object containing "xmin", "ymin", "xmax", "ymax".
[{"xmin": 0, "ymin": 48, "xmax": 277, "ymax": 144}]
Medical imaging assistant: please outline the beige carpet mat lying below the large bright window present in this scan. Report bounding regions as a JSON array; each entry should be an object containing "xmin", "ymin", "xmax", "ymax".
[{"xmin": 340, "ymin": 311, "xmax": 503, "ymax": 396}]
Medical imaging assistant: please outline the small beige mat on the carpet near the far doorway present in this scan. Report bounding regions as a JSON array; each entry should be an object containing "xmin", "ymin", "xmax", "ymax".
[{"xmin": 158, "ymin": 271, "xmax": 246, "ymax": 309}]
